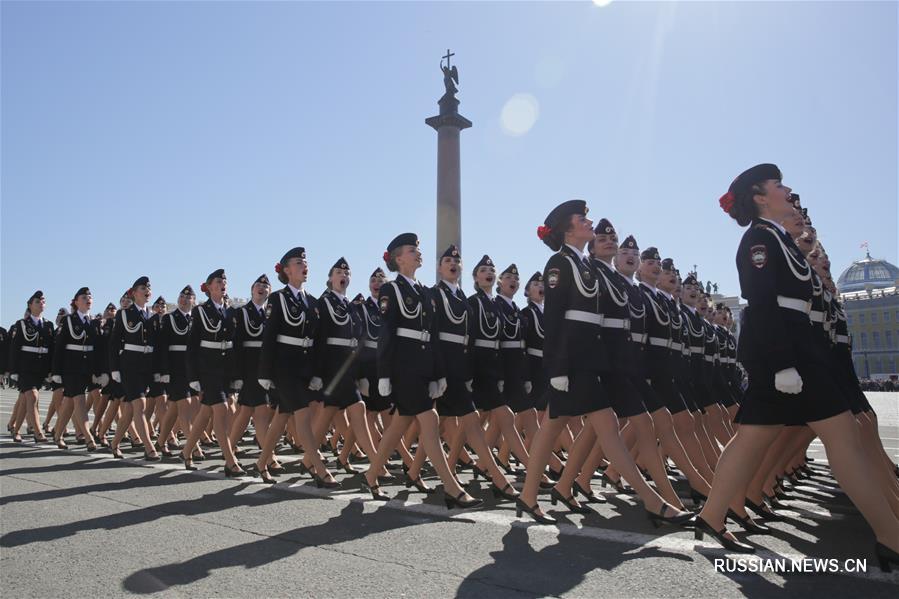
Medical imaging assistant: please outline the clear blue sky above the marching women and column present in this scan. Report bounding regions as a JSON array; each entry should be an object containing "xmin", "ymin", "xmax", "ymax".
[{"xmin": 0, "ymin": 1, "xmax": 899, "ymax": 326}]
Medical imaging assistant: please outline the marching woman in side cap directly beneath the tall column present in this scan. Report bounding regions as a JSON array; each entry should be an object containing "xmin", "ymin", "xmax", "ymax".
[{"xmin": 430, "ymin": 245, "xmax": 518, "ymax": 500}]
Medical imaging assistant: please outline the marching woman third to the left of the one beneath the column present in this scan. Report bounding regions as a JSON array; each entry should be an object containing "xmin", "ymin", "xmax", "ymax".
[{"xmin": 309, "ymin": 257, "xmax": 386, "ymax": 474}]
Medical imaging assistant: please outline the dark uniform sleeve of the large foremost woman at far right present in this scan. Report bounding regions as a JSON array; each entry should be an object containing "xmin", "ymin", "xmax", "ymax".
[{"xmin": 737, "ymin": 226, "xmax": 796, "ymax": 372}]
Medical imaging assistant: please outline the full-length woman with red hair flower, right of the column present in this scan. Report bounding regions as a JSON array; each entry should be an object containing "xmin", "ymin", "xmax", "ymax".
[{"xmin": 516, "ymin": 200, "xmax": 693, "ymax": 525}]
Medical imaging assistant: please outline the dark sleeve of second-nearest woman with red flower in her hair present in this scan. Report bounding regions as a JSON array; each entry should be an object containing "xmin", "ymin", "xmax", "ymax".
[{"xmin": 543, "ymin": 253, "xmax": 574, "ymax": 379}]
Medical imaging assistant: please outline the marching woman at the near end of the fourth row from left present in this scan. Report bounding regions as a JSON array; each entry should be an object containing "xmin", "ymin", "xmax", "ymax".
[{"xmin": 181, "ymin": 268, "xmax": 246, "ymax": 477}]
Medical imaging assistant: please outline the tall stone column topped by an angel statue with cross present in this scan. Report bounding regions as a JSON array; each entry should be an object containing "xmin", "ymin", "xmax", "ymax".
[{"xmin": 425, "ymin": 50, "xmax": 471, "ymax": 274}]
